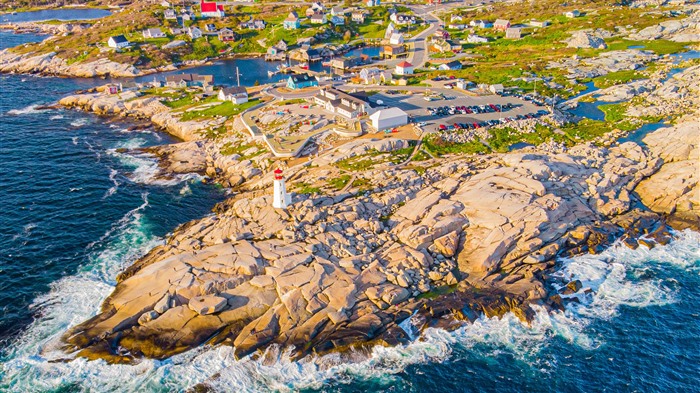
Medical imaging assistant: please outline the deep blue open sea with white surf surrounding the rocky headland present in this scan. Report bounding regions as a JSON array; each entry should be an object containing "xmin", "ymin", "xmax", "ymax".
[{"xmin": 0, "ymin": 29, "xmax": 700, "ymax": 392}]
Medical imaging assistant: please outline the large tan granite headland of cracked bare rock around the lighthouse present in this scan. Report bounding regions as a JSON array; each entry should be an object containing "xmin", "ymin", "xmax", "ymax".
[{"xmin": 57, "ymin": 115, "xmax": 700, "ymax": 362}]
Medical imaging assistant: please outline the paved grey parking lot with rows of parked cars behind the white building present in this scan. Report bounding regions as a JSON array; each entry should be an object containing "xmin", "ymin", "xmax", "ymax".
[{"xmin": 370, "ymin": 88, "xmax": 545, "ymax": 131}]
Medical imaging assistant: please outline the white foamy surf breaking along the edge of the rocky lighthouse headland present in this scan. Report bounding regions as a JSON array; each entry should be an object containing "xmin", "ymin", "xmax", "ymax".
[{"xmin": 0, "ymin": 231, "xmax": 700, "ymax": 392}]
